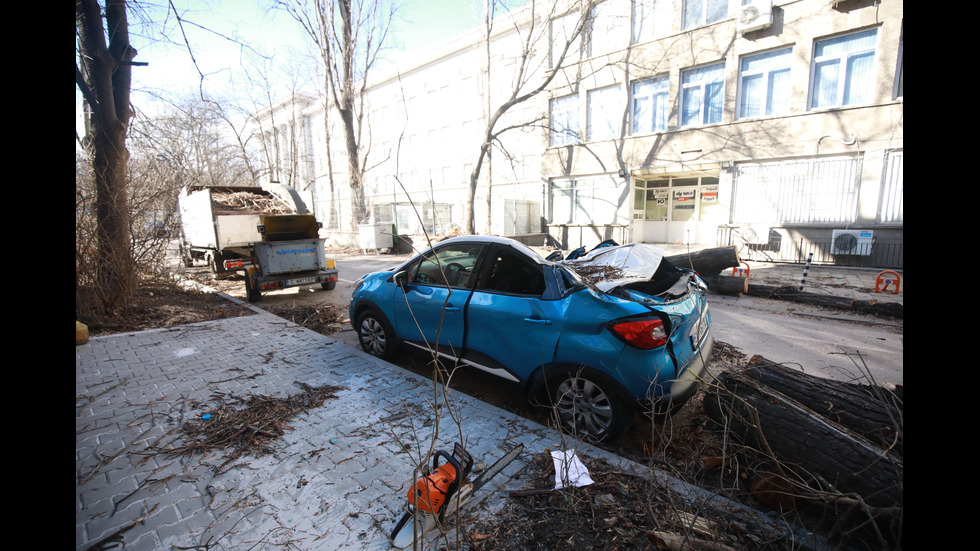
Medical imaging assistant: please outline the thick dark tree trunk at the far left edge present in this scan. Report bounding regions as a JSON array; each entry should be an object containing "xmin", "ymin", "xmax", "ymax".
[{"xmin": 75, "ymin": 0, "xmax": 142, "ymax": 311}]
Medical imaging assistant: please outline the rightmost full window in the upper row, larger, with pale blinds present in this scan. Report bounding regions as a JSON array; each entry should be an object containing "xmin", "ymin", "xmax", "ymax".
[{"xmin": 810, "ymin": 29, "xmax": 877, "ymax": 109}]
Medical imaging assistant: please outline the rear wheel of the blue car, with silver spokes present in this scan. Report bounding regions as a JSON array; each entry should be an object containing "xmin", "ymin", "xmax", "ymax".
[{"xmin": 552, "ymin": 373, "xmax": 630, "ymax": 442}]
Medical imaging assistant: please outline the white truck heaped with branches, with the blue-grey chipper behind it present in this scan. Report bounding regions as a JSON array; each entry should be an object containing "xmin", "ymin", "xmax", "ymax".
[{"xmin": 178, "ymin": 184, "xmax": 338, "ymax": 302}]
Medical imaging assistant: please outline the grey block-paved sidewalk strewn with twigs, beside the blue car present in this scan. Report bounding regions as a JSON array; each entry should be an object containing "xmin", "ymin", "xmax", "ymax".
[{"xmin": 75, "ymin": 313, "xmax": 660, "ymax": 550}]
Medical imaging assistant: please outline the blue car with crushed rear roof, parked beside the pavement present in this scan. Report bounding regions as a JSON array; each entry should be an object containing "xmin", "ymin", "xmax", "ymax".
[{"xmin": 350, "ymin": 236, "xmax": 714, "ymax": 441}]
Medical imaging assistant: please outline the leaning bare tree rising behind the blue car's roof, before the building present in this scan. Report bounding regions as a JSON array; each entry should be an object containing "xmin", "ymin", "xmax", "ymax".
[{"xmin": 465, "ymin": 0, "xmax": 597, "ymax": 234}]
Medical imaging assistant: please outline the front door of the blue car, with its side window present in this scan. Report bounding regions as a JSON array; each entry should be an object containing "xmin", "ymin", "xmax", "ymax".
[{"xmin": 393, "ymin": 243, "xmax": 483, "ymax": 357}]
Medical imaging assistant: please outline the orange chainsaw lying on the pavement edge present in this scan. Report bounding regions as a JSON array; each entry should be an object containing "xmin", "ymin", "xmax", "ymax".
[{"xmin": 389, "ymin": 443, "xmax": 524, "ymax": 549}]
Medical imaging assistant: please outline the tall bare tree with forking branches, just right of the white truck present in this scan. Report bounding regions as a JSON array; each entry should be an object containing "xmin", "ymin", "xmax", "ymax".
[{"xmin": 278, "ymin": 0, "xmax": 395, "ymax": 229}]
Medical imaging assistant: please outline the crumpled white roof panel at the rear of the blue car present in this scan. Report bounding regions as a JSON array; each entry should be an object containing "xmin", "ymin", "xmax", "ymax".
[{"xmin": 560, "ymin": 243, "xmax": 664, "ymax": 293}]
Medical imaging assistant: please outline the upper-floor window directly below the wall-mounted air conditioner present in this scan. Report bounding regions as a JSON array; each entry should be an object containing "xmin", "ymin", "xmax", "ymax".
[{"xmin": 738, "ymin": 48, "xmax": 793, "ymax": 119}]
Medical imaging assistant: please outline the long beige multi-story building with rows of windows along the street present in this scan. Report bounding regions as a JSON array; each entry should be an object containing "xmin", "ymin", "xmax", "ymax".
[{"xmin": 255, "ymin": 0, "xmax": 904, "ymax": 267}]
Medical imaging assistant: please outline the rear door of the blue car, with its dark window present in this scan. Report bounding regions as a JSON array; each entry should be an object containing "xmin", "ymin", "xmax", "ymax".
[{"xmin": 463, "ymin": 246, "xmax": 562, "ymax": 382}]
